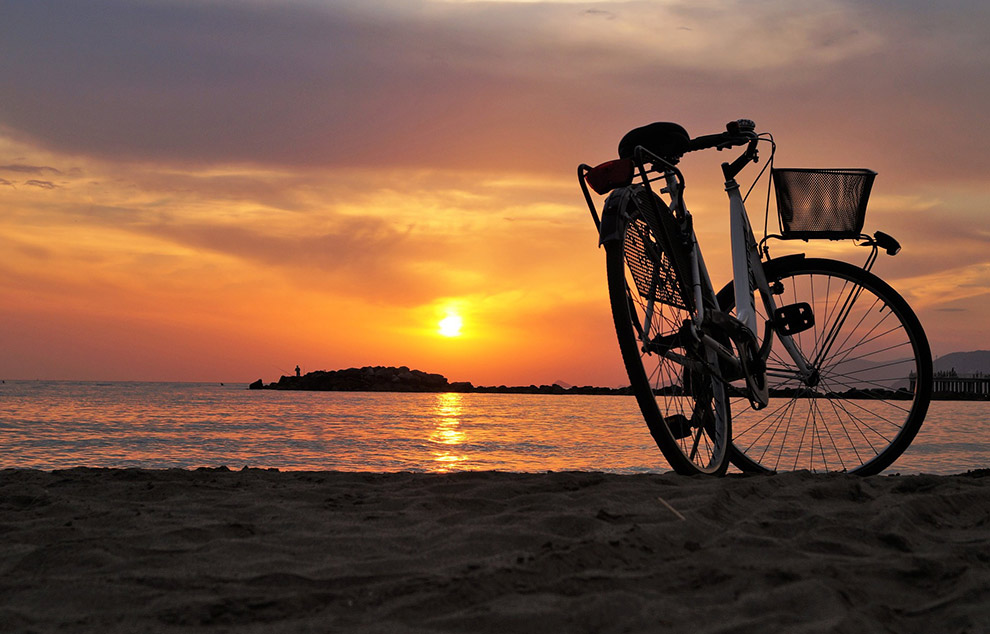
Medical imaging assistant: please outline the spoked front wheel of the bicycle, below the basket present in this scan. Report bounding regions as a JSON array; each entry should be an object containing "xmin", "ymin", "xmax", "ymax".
[{"xmin": 718, "ymin": 257, "xmax": 933, "ymax": 475}]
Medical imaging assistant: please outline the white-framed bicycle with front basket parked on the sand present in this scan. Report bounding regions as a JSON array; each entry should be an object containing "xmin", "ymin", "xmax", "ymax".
[{"xmin": 578, "ymin": 119, "xmax": 932, "ymax": 475}]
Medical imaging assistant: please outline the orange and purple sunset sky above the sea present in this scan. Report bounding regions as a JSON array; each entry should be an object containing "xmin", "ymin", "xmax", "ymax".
[{"xmin": 0, "ymin": 0, "xmax": 990, "ymax": 385}]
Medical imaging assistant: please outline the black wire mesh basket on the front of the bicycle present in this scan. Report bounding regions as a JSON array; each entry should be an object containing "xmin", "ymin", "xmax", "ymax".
[{"xmin": 773, "ymin": 168, "xmax": 877, "ymax": 240}]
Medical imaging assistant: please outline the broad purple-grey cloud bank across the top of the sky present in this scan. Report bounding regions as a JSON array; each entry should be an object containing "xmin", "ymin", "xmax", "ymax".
[{"xmin": 0, "ymin": 0, "xmax": 990, "ymax": 180}]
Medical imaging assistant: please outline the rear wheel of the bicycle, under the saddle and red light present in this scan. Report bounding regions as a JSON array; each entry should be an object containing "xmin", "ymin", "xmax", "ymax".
[{"xmin": 604, "ymin": 188, "xmax": 731, "ymax": 475}]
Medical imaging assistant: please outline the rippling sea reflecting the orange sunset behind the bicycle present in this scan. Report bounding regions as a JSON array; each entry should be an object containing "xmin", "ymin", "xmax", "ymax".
[{"xmin": 0, "ymin": 381, "xmax": 990, "ymax": 475}]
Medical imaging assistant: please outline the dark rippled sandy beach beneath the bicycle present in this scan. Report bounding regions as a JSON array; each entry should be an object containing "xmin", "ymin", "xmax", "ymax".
[{"xmin": 0, "ymin": 468, "xmax": 990, "ymax": 634}]
